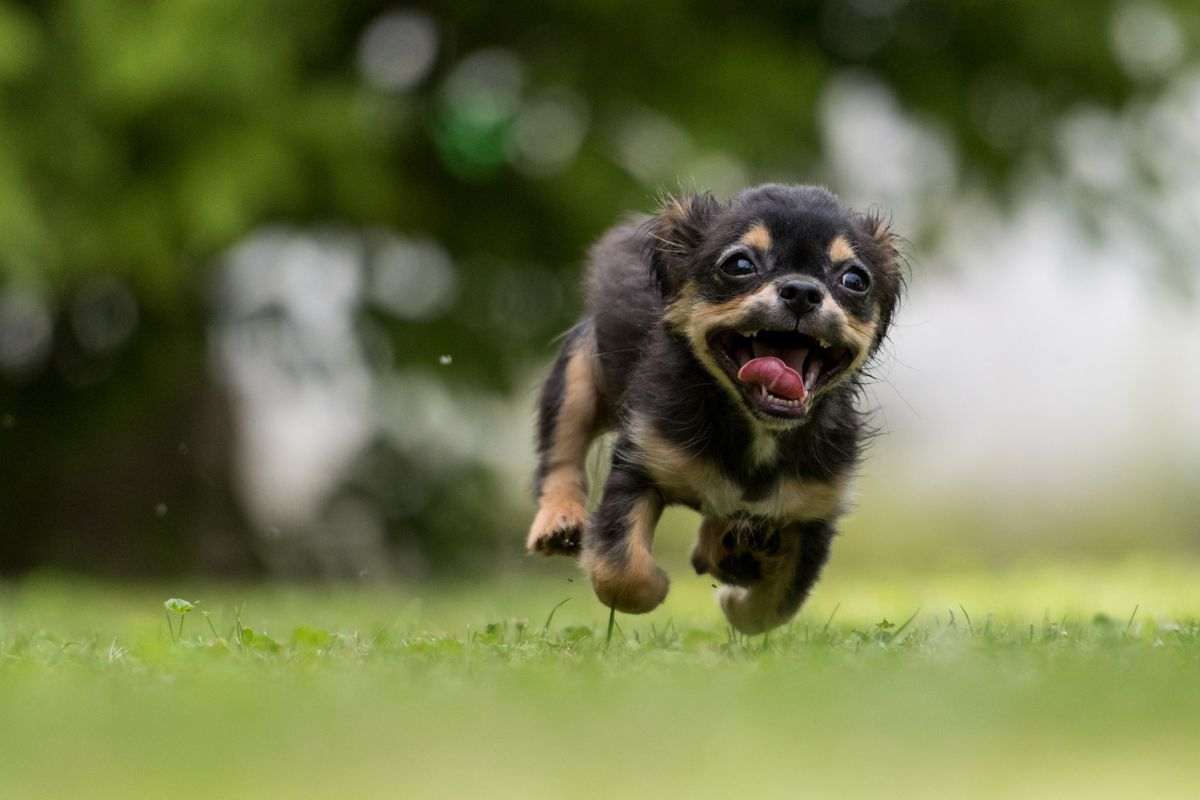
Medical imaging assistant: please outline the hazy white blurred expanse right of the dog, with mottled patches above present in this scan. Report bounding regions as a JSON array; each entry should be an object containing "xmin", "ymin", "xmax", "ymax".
[{"xmin": 822, "ymin": 73, "xmax": 1200, "ymax": 506}]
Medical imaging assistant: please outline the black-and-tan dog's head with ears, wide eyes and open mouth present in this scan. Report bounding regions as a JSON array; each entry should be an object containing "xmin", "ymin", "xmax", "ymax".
[{"xmin": 650, "ymin": 186, "xmax": 902, "ymax": 428}]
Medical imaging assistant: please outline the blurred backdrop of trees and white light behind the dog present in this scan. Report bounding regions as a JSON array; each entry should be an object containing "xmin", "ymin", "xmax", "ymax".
[{"xmin": 0, "ymin": 0, "xmax": 1200, "ymax": 581}]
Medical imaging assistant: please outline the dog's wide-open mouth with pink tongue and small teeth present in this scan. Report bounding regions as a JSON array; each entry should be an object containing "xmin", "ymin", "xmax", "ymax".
[{"xmin": 709, "ymin": 330, "xmax": 854, "ymax": 417}]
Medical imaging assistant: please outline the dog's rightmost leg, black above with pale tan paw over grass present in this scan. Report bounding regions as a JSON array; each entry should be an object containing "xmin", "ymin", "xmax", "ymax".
[{"xmin": 718, "ymin": 521, "xmax": 834, "ymax": 633}]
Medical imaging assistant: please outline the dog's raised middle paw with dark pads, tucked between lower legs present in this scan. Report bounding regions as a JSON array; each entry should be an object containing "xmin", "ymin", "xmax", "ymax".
[{"xmin": 691, "ymin": 516, "xmax": 784, "ymax": 587}]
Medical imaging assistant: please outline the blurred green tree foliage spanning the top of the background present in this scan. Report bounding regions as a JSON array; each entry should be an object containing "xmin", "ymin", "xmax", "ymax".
[{"xmin": 0, "ymin": 0, "xmax": 1195, "ymax": 316}]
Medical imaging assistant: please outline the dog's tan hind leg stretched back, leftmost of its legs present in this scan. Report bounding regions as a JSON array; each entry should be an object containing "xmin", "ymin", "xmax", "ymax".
[{"xmin": 526, "ymin": 321, "xmax": 600, "ymax": 555}]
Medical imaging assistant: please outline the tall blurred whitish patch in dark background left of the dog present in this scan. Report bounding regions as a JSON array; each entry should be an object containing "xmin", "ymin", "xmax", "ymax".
[{"xmin": 210, "ymin": 229, "xmax": 372, "ymax": 531}]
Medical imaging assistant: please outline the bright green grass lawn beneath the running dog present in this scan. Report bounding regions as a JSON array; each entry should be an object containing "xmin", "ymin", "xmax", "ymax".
[{"xmin": 0, "ymin": 559, "xmax": 1200, "ymax": 799}]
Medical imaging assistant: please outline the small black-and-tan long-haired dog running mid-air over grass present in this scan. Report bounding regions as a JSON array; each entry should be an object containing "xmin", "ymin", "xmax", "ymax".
[{"xmin": 526, "ymin": 184, "xmax": 904, "ymax": 633}]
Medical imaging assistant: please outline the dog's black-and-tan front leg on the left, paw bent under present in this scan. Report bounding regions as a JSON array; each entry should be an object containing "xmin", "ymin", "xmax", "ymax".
[{"xmin": 583, "ymin": 440, "xmax": 670, "ymax": 614}]
